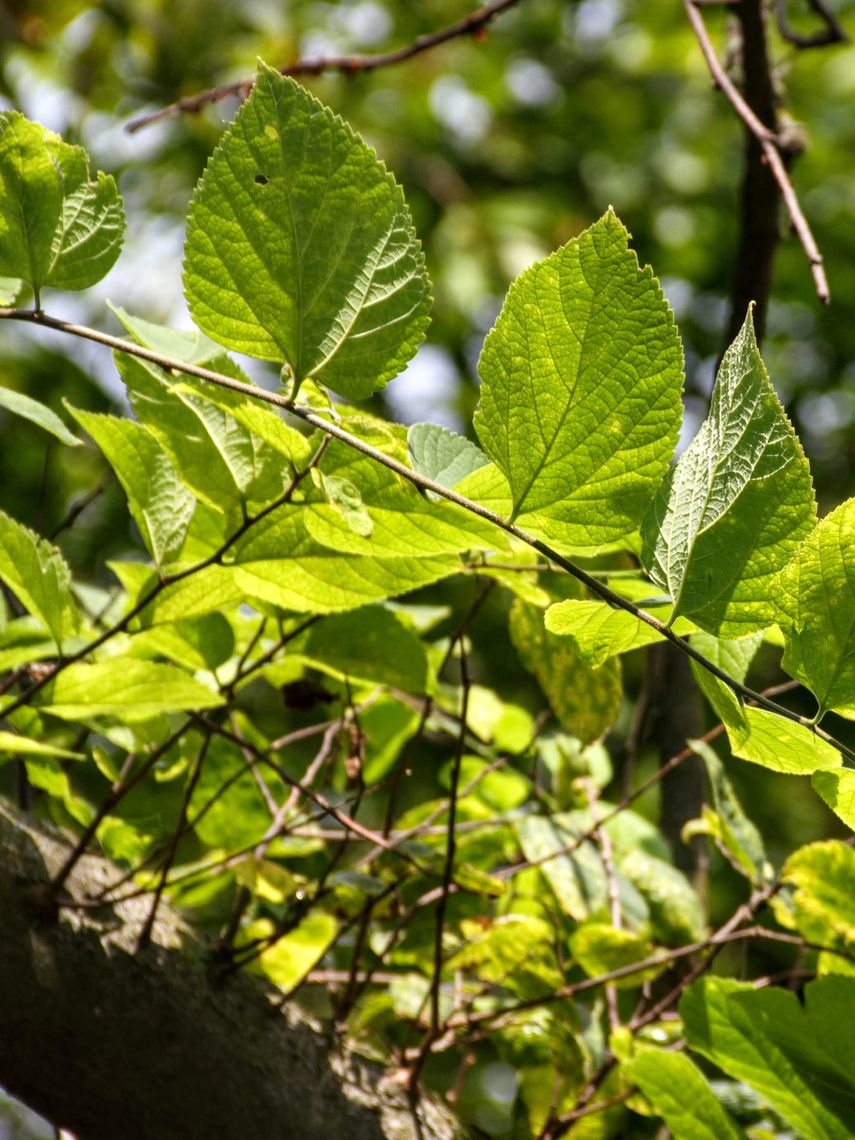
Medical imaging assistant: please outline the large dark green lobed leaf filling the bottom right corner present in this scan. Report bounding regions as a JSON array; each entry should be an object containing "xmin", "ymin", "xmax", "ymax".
[{"xmin": 679, "ymin": 977, "xmax": 855, "ymax": 1140}]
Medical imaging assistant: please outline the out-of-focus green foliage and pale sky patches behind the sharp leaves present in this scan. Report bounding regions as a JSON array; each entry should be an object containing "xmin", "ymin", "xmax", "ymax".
[{"xmin": 0, "ymin": 0, "xmax": 855, "ymax": 1130}]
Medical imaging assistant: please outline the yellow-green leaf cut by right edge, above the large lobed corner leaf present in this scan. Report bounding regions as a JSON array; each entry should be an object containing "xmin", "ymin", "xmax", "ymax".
[{"xmin": 781, "ymin": 839, "xmax": 855, "ymax": 961}]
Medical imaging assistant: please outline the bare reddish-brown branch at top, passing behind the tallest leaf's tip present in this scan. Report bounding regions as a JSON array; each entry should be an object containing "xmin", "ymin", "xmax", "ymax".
[{"xmin": 125, "ymin": 0, "xmax": 528, "ymax": 133}]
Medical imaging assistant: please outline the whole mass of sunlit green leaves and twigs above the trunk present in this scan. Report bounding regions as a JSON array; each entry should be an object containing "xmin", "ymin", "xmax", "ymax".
[{"xmin": 0, "ymin": 66, "xmax": 855, "ymax": 1138}]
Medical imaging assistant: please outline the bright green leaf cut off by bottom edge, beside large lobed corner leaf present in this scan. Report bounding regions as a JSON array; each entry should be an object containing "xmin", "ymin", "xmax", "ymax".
[{"xmin": 622, "ymin": 1049, "xmax": 744, "ymax": 1140}]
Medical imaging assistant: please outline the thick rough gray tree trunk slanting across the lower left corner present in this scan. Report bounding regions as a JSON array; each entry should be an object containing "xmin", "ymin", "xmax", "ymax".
[{"xmin": 0, "ymin": 806, "xmax": 456, "ymax": 1140}]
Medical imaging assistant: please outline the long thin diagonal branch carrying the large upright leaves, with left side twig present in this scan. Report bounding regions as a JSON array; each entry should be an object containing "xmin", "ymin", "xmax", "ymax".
[{"xmin": 0, "ymin": 309, "xmax": 855, "ymax": 765}]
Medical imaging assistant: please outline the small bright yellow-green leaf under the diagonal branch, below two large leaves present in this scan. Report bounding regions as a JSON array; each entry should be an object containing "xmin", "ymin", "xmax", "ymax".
[{"xmin": 546, "ymin": 597, "xmax": 694, "ymax": 668}]
